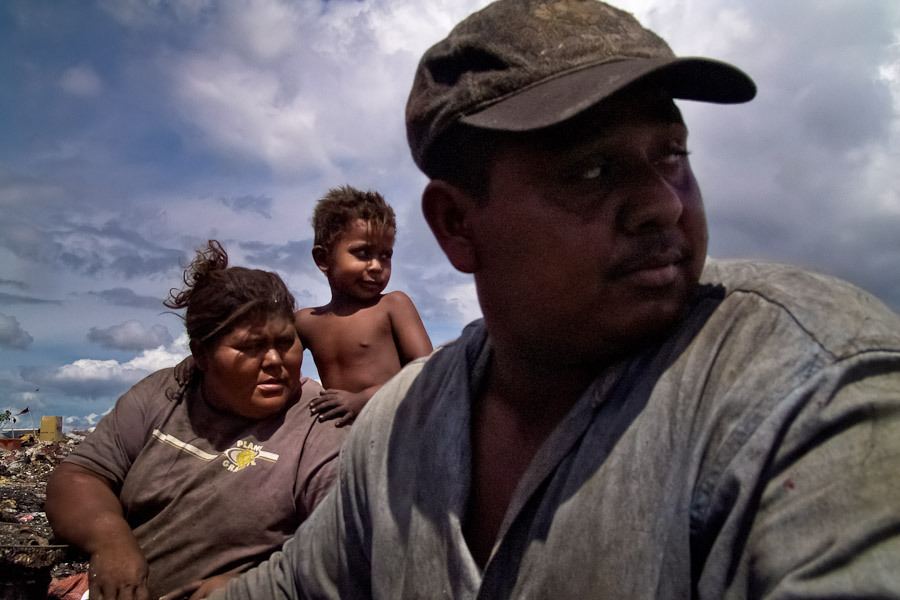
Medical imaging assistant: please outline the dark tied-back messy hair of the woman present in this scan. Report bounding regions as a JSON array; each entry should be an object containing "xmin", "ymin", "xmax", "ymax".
[{"xmin": 163, "ymin": 240, "xmax": 296, "ymax": 347}]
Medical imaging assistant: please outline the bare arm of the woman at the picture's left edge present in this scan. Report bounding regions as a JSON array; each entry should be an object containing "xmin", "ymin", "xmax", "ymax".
[{"xmin": 46, "ymin": 463, "xmax": 149, "ymax": 600}]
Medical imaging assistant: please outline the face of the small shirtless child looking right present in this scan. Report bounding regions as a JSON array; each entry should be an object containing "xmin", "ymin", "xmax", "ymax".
[{"xmin": 320, "ymin": 219, "xmax": 394, "ymax": 301}]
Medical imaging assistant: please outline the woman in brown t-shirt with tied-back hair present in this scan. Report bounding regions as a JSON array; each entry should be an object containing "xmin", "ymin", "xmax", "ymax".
[{"xmin": 46, "ymin": 240, "xmax": 344, "ymax": 600}]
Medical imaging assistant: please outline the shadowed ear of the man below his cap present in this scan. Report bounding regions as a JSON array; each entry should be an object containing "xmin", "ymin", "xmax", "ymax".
[{"xmin": 422, "ymin": 179, "xmax": 478, "ymax": 273}]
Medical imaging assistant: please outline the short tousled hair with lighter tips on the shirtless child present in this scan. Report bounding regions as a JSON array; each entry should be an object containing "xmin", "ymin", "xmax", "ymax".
[{"xmin": 312, "ymin": 185, "xmax": 397, "ymax": 250}]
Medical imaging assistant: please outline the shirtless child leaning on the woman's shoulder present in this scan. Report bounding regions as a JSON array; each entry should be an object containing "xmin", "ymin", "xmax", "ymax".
[{"xmin": 295, "ymin": 186, "xmax": 432, "ymax": 427}]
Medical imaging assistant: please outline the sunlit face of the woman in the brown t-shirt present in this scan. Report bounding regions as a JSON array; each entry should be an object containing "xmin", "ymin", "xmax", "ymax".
[{"xmin": 192, "ymin": 315, "xmax": 303, "ymax": 419}]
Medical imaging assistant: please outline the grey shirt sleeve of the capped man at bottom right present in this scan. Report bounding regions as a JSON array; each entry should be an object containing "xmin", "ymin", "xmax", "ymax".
[{"xmin": 701, "ymin": 352, "xmax": 900, "ymax": 599}]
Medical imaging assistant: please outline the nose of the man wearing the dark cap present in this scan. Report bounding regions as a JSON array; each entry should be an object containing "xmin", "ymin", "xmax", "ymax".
[{"xmin": 619, "ymin": 166, "xmax": 684, "ymax": 234}]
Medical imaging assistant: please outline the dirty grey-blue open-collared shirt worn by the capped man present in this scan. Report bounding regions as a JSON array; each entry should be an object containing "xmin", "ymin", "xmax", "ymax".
[{"xmin": 213, "ymin": 261, "xmax": 900, "ymax": 600}]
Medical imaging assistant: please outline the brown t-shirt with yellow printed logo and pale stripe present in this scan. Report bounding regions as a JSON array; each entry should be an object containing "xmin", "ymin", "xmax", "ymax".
[{"xmin": 67, "ymin": 358, "xmax": 346, "ymax": 598}]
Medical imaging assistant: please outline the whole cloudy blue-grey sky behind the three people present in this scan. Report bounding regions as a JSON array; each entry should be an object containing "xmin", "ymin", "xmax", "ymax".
[{"xmin": 0, "ymin": 0, "xmax": 900, "ymax": 430}]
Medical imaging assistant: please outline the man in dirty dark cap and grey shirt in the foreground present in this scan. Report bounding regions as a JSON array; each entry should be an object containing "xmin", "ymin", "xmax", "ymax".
[{"xmin": 213, "ymin": 0, "xmax": 900, "ymax": 600}]
